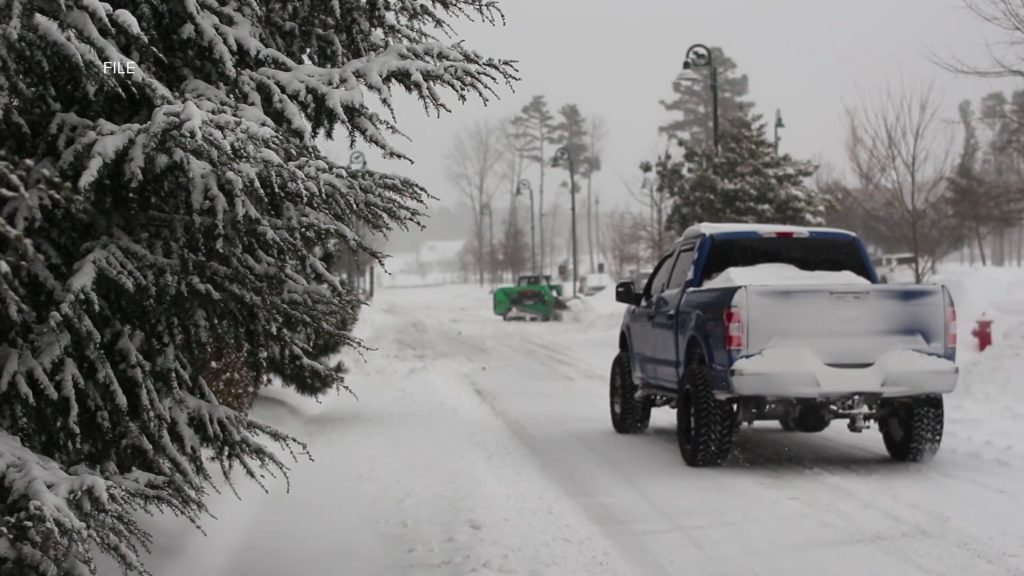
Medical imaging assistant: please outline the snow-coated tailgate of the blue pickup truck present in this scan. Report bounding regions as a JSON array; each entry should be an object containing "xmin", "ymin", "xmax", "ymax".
[{"xmin": 734, "ymin": 284, "xmax": 946, "ymax": 368}]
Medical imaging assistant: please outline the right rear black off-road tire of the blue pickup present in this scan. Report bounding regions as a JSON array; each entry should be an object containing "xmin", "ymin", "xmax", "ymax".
[{"xmin": 879, "ymin": 396, "xmax": 944, "ymax": 462}]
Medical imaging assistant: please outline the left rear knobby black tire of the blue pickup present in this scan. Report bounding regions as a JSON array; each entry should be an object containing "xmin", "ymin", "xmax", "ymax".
[{"xmin": 676, "ymin": 350, "xmax": 736, "ymax": 466}]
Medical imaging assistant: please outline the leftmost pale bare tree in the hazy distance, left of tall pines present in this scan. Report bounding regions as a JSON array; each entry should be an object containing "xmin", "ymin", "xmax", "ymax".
[{"xmin": 447, "ymin": 122, "xmax": 503, "ymax": 286}]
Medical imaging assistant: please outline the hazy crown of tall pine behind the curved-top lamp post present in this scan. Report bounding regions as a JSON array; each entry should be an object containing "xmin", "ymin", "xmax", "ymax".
[{"xmin": 658, "ymin": 47, "xmax": 754, "ymax": 149}]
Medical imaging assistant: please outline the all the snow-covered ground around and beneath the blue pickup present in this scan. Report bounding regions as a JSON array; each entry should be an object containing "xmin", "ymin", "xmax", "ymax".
[{"xmin": 123, "ymin": 266, "xmax": 1024, "ymax": 576}]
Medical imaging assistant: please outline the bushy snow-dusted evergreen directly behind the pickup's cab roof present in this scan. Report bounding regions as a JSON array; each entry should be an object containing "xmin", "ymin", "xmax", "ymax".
[{"xmin": 655, "ymin": 116, "xmax": 826, "ymax": 233}]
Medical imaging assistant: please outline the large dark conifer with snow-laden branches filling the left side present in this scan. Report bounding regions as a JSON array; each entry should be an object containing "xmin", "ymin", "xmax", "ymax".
[{"xmin": 0, "ymin": 0, "xmax": 514, "ymax": 575}]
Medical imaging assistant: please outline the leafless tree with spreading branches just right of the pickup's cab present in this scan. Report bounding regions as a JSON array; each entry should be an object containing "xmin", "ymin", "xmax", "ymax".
[{"xmin": 847, "ymin": 84, "xmax": 959, "ymax": 282}]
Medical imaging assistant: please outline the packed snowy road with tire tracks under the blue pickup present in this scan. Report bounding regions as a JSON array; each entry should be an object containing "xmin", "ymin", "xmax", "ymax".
[{"xmin": 390, "ymin": 282, "xmax": 1024, "ymax": 575}]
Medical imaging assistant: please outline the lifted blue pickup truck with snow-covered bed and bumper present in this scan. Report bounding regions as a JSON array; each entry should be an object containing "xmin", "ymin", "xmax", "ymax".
[{"xmin": 609, "ymin": 223, "xmax": 957, "ymax": 466}]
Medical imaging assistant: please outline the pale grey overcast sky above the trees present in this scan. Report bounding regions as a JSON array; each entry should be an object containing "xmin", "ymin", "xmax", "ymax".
[{"xmin": 317, "ymin": 0, "xmax": 1022, "ymax": 215}]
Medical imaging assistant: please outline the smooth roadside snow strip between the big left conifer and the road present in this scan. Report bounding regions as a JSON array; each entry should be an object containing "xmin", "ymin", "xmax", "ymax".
[{"xmin": 132, "ymin": 287, "xmax": 630, "ymax": 576}]
